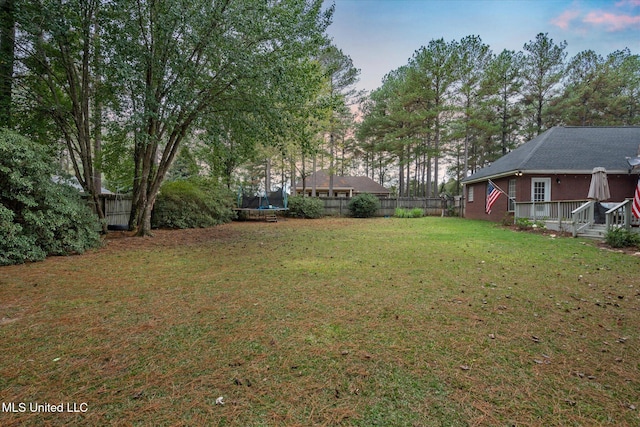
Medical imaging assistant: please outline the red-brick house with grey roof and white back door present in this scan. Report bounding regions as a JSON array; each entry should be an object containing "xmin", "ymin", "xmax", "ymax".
[{"xmin": 463, "ymin": 127, "xmax": 640, "ymax": 229}]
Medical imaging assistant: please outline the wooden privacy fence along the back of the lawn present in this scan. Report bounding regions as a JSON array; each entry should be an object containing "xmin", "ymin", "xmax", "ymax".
[{"xmin": 320, "ymin": 197, "xmax": 460, "ymax": 216}]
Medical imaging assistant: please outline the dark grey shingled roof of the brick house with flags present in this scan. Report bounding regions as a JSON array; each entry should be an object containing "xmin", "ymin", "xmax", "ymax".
[{"xmin": 463, "ymin": 126, "xmax": 640, "ymax": 183}]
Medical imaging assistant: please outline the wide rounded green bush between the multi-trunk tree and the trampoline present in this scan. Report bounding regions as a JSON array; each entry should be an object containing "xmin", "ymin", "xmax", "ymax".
[{"xmin": 151, "ymin": 177, "xmax": 233, "ymax": 228}]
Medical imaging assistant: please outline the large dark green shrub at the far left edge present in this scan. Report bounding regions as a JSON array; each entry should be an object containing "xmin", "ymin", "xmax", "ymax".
[{"xmin": 0, "ymin": 130, "xmax": 100, "ymax": 265}]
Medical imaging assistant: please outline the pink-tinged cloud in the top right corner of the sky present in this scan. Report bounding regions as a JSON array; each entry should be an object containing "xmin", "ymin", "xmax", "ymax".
[{"xmin": 551, "ymin": 0, "xmax": 640, "ymax": 33}]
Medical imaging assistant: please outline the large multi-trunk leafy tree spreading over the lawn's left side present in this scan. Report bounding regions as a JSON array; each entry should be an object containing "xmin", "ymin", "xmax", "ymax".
[{"xmin": 110, "ymin": 0, "xmax": 332, "ymax": 235}]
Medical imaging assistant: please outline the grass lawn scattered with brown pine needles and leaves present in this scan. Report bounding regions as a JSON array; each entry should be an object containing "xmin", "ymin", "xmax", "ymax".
[{"xmin": 0, "ymin": 218, "xmax": 640, "ymax": 426}]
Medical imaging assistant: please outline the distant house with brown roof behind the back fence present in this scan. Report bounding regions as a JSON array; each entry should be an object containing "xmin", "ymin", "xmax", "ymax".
[{"xmin": 296, "ymin": 170, "xmax": 391, "ymax": 198}]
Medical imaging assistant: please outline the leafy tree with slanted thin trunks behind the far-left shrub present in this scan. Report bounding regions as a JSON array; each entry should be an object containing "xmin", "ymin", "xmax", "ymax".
[{"xmin": 16, "ymin": 0, "xmax": 110, "ymax": 231}]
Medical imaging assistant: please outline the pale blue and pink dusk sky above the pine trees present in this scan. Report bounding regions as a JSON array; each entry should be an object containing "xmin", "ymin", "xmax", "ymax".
[{"xmin": 325, "ymin": 0, "xmax": 640, "ymax": 91}]
